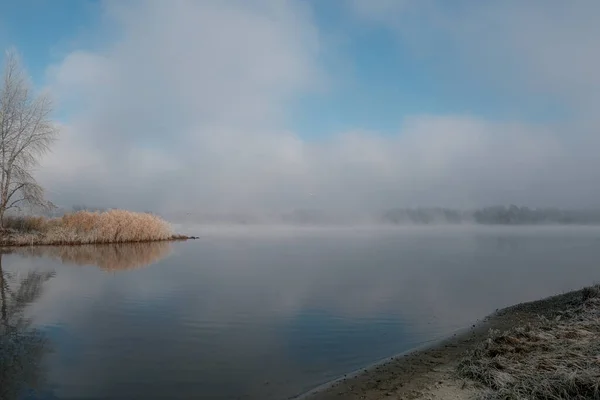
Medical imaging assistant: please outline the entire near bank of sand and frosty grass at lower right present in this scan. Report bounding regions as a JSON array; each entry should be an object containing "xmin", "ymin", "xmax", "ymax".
[{"xmin": 306, "ymin": 285, "xmax": 600, "ymax": 400}]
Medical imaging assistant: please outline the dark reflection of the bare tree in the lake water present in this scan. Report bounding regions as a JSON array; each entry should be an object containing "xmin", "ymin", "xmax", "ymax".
[{"xmin": 0, "ymin": 253, "xmax": 54, "ymax": 399}]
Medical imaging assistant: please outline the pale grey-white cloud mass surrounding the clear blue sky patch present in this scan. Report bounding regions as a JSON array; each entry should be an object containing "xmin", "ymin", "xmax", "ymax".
[{"xmin": 38, "ymin": 0, "xmax": 600, "ymax": 212}]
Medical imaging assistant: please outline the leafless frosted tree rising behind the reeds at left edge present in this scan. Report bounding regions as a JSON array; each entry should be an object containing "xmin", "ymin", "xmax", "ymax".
[{"xmin": 0, "ymin": 50, "xmax": 58, "ymax": 228}]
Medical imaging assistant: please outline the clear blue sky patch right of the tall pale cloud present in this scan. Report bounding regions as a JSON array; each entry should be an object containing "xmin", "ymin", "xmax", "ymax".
[{"xmin": 294, "ymin": 1, "xmax": 566, "ymax": 138}]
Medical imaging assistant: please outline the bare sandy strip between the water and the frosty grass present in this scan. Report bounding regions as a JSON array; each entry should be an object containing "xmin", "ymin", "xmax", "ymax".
[{"xmin": 304, "ymin": 286, "xmax": 600, "ymax": 400}]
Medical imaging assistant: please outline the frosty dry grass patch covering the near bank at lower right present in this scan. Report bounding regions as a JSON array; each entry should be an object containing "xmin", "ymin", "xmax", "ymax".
[{"xmin": 457, "ymin": 285, "xmax": 600, "ymax": 400}]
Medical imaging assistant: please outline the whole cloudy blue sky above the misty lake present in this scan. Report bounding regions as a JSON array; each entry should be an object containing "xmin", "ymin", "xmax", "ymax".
[{"xmin": 0, "ymin": 0, "xmax": 600, "ymax": 212}]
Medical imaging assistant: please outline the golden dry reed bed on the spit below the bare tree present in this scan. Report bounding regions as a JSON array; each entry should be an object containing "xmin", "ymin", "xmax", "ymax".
[{"xmin": 0, "ymin": 210, "xmax": 184, "ymax": 246}]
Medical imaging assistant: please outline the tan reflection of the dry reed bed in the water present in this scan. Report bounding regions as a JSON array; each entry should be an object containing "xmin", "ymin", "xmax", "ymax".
[{"xmin": 14, "ymin": 242, "xmax": 172, "ymax": 271}]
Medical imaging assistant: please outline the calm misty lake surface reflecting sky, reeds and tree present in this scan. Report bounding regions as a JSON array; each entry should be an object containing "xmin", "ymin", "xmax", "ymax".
[{"xmin": 0, "ymin": 226, "xmax": 600, "ymax": 400}]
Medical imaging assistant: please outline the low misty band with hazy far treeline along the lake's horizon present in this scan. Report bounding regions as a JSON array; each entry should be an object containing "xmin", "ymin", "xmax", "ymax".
[{"xmin": 163, "ymin": 205, "xmax": 600, "ymax": 226}]
